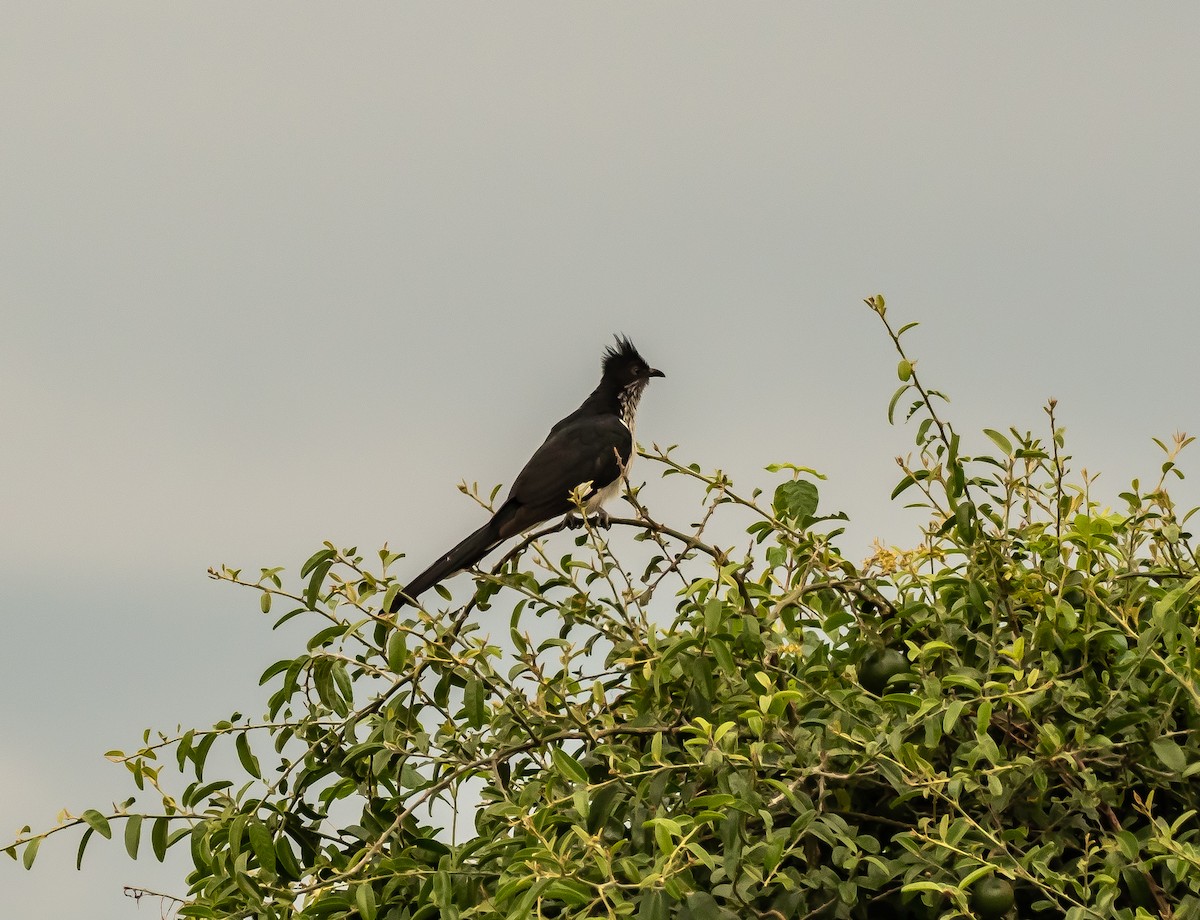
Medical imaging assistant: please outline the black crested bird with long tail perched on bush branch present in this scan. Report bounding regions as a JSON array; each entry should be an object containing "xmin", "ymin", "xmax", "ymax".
[{"xmin": 388, "ymin": 336, "xmax": 666, "ymax": 612}]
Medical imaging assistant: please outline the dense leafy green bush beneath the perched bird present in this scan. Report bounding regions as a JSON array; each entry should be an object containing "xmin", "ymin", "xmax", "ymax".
[{"xmin": 7, "ymin": 297, "xmax": 1200, "ymax": 920}]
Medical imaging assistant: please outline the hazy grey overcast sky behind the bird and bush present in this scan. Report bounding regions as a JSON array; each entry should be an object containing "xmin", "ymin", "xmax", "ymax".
[{"xmin": 0, "ymin": 0, "xmax": 1200, "ymax": 920}]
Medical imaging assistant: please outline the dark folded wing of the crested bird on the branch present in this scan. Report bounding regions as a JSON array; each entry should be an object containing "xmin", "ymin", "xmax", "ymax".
[{"xmin": 498, "ymin": 415, "xmax": 634, "ymax": 536}]
